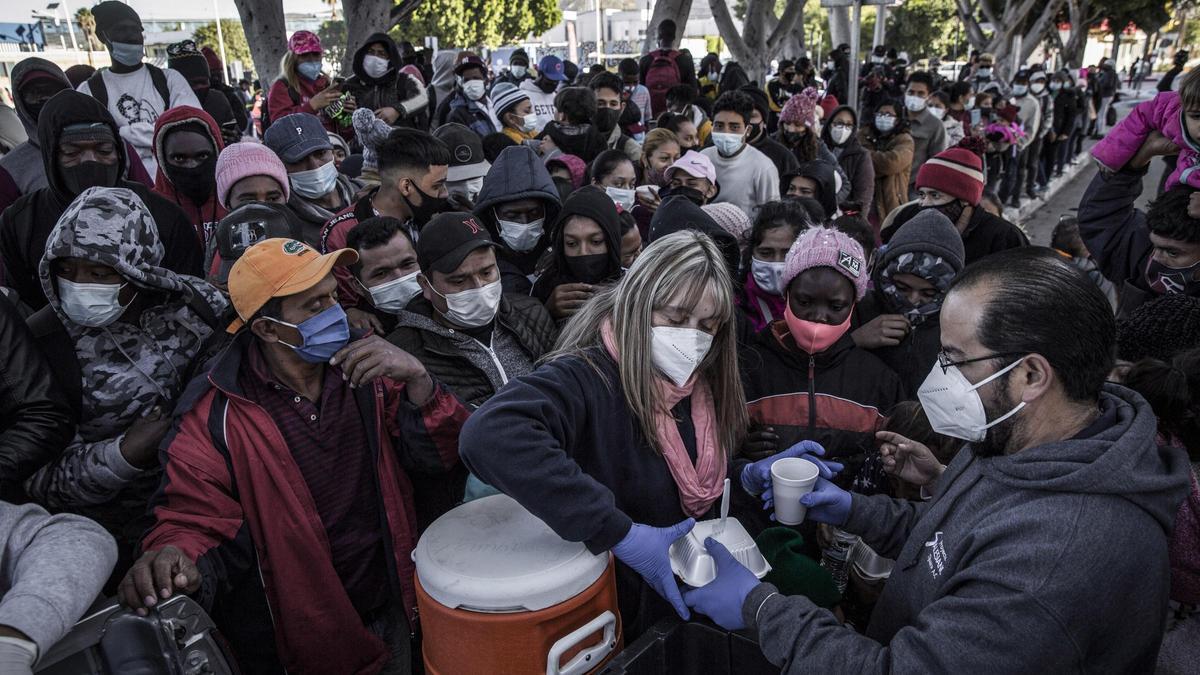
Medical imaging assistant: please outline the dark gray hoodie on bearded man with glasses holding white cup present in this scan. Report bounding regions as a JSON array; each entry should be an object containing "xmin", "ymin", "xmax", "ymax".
[{"xmin": 742, "ymin": 386, "xmax": 1189, "ymax": 673}]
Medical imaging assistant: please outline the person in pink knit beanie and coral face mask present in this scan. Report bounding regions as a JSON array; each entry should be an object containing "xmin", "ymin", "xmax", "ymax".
[{"xmin": 740, "ymin": 226, "xmax": 905, "ymax": 494}]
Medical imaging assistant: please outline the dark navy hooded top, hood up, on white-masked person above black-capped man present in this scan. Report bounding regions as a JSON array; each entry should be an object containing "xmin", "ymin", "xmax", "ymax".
[{"xmin": 475, "ymin": 145, "xmax": 562, "ymax": 295}]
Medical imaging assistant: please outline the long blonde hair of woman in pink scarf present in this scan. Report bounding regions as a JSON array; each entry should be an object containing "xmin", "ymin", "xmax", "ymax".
[{"xmin": 546, "ymin": 231, "xmax": 749, "ymax": 456}]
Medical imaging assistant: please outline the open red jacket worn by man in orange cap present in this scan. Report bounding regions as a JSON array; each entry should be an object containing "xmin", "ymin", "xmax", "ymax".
[{"xmin": 142, "ymin": 331, "xmax": 468, "ymax": 674}]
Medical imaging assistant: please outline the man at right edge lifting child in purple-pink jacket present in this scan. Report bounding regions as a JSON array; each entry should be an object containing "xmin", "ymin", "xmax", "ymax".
[{"xmin": 1079, "ymin": 132, "xmax": 1200, "ymax": 318}]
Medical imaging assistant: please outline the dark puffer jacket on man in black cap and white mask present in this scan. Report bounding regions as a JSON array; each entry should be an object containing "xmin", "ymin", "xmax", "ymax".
[{"xmin": 388, "ymin": 294, "xmax": 558, "ymax": 410}]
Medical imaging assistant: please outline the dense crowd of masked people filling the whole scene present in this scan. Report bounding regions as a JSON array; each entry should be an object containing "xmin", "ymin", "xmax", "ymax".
[{"xmin": 0, "ymin": 0, "xmax": 1200, "ymax": 674}]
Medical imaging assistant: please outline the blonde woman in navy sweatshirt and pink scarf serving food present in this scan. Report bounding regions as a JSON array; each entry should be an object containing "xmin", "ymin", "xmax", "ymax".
[{"xmin": 460, "ymin": 231, "xmax": 827, "ymax": 639}]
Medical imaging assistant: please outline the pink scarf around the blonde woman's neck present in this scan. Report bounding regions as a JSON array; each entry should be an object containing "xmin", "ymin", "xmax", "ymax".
[{"xmin": 600, "ymin": 319, "xmax": 726, "ymax": 518}]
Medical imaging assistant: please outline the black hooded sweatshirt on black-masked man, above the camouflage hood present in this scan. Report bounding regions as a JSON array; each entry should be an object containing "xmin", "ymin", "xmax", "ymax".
[{"xmin": 0, "ymin": 91, "xmax": 204, "ymax": 310}]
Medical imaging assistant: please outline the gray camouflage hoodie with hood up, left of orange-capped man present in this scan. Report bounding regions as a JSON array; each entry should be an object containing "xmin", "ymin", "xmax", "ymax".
[{"xmin": 26, "ymin": 187, "xmax": 226, "ymax": 508}]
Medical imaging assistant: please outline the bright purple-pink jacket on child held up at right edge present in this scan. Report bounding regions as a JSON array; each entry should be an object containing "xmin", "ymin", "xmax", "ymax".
[{"xmin": 1092, "ymin": 91, "xmax": 1200, "ymax": 190}]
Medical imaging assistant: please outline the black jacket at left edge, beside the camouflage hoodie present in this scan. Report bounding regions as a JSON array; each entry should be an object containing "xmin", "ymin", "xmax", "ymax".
[{"xmin": 0, "ymin": 298, "xmax": 74, "ymax": 503}]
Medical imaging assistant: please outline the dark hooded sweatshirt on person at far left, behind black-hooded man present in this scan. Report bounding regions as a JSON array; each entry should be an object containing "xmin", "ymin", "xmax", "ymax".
[{"xmin": 0, "ymin": 56, "xmax": 151, "ymax": 211}]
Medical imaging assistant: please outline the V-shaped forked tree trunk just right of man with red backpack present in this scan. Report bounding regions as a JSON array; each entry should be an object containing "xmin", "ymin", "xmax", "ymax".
[{"xmin": 708, "ymin": 0, "xmax": 804, "ymax": 83}]
